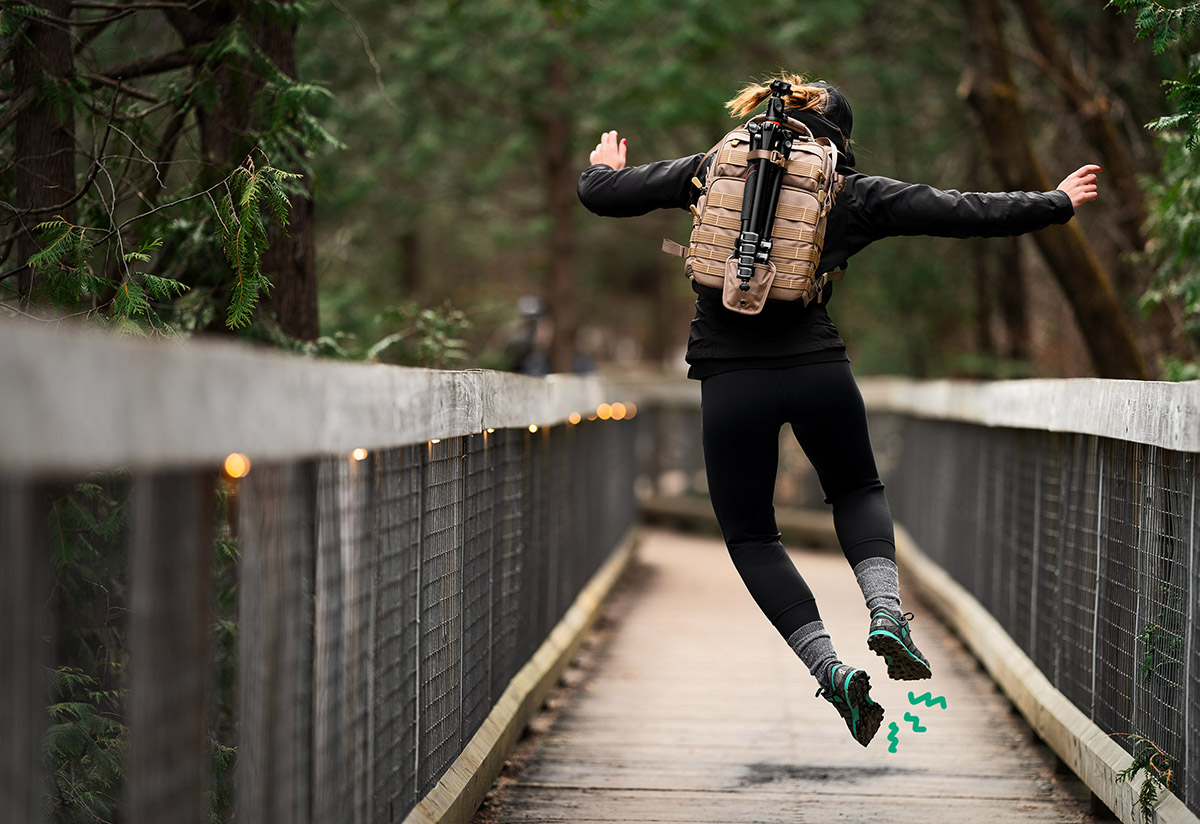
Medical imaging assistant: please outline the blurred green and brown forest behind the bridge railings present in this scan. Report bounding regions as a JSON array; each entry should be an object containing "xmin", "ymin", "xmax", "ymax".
[{"xmin": 0, "ymin": 0, "xmax": 1200, "ymax": 379}]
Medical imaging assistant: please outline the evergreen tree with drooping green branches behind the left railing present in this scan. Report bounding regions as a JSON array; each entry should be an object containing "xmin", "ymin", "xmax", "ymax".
[{"xmin": 0, "ymin": 0, "xmax": 336, "ymax": 339}]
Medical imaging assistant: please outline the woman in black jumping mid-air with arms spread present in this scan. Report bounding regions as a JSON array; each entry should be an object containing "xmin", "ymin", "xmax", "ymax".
[{"xmin": 578, "ymin": 74, "xmax": 1100, "ymax": 746}]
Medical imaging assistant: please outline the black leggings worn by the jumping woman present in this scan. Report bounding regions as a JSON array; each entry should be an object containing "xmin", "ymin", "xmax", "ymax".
[{"xmin": 701, "ymin": 361, "xmax": 895, "ymax": 638}]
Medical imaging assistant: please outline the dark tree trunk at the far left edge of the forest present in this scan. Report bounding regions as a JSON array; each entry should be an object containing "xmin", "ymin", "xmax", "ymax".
[{"xmin": 13, "ymin": 0, "xmax": 76, "ymax": 309}]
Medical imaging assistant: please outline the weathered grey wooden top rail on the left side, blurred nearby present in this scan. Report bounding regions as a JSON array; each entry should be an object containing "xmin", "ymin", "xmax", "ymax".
[{"xmin": 0, "ymin": 326, "xmax": 631, "ymax": 473}]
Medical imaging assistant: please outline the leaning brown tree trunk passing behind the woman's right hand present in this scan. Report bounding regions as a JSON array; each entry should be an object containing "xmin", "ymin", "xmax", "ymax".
[{"xmin": 960, "ymin": 0, "xmax": 1148, "ymax": 379}]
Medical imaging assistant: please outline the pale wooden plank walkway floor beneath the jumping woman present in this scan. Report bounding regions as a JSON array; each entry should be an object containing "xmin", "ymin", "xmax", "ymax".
[{"xmin": 476, "ymin": 530, "xmax": 1096, "ymax": 824}]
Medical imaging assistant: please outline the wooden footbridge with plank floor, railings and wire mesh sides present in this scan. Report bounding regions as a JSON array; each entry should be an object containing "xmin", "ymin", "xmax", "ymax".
[{"xmin": 0, "ymin": 327, "xmax": 1200, "ymax": 824}]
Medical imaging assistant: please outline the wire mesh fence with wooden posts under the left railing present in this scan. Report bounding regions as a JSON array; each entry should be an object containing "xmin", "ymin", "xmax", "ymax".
[{"xmin": 0, "ymin": 420, "xmax": 640, "ymax": 824}]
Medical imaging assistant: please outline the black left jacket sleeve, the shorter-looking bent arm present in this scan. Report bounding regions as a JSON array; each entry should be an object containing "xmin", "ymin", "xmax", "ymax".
[{"xmin": 577, "ymin": 154, "xmax": 704, "ymax": 217}]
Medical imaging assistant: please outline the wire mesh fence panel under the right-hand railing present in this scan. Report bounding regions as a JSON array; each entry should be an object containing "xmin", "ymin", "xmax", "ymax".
[{"xmin": 872, "ymin": 417, "xmax": 1200, "ymax": 811}]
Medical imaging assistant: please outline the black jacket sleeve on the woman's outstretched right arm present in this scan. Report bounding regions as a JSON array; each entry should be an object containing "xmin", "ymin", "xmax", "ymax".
[{"xmin": 838, "ymin": 174, "xmax": 1075, "ymax": 254}]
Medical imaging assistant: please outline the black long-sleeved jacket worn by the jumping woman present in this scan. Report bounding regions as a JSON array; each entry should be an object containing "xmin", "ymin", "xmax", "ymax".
[{"xmin": 578, "ymin": 154, "xmax": 1074, "ymax": 377}]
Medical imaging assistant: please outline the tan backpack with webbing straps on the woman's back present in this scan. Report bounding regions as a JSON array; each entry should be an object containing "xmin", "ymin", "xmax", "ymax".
[{"xmin": 662, "ymin": 115, "xmax": 845, "ymax": 314}]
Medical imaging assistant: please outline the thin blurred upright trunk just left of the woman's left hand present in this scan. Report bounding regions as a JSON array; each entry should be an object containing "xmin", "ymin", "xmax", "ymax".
[{"xmin": 542, "ymin": 54, "xmax": 578, "ymax": 372}]
